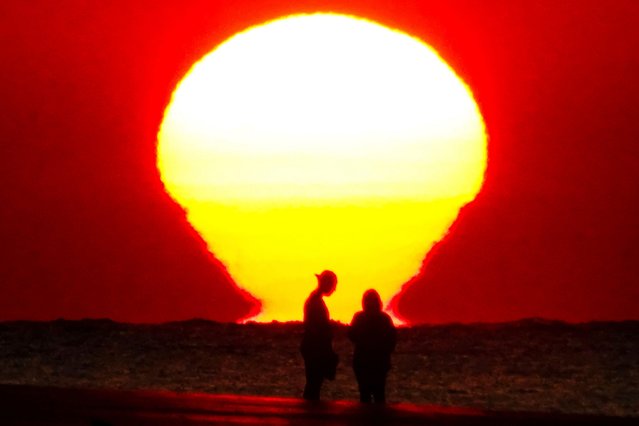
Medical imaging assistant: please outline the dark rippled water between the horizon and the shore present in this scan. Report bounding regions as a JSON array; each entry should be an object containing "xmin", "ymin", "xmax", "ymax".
[{"xmin": 0, "ymin": 320, "xmax": 639, "ymax": 416}]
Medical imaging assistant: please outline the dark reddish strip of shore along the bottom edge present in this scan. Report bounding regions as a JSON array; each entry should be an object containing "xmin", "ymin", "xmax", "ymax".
[{"xmin": 0, "ymin": 385, "xmax": 639, "ymax": 426}]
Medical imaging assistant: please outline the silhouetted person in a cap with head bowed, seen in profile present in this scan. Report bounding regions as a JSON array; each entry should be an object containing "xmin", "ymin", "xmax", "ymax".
[{"xmin": 300, "ymin": 271, "xmax": 338, "ymax": 401}]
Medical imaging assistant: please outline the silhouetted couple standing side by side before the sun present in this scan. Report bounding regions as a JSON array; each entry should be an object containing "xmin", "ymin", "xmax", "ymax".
[{"xmin": 301, "ymin": 271, "xmax": 396, "ymax": 403}]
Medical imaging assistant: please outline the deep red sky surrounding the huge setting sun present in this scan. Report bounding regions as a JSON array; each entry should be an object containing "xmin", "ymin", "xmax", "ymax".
[{"xmin": 0, "ymin": 0, "xmax": 639, "ymax": 322}]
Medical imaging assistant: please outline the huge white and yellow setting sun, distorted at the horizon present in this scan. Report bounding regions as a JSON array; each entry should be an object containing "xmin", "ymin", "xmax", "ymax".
[{"xmin": 158, "ymin": 14, "xmax": 487, "ymax": 322}]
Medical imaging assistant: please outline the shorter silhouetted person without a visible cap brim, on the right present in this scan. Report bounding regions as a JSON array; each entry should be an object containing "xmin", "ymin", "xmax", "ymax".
[{"xmin": 348, "ymin": 290, "xmax": 397, "ymax": 404}]
